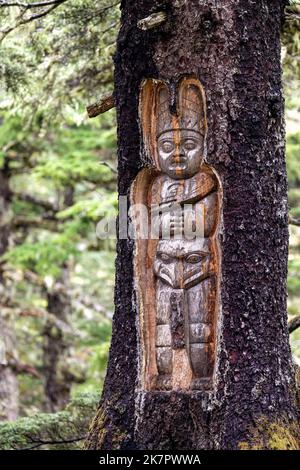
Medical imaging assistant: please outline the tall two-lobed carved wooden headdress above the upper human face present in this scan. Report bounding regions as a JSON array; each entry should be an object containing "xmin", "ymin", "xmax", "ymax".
[{"xmin": 140, "ymin": 77, "xmax": 207, "ymax": 169}]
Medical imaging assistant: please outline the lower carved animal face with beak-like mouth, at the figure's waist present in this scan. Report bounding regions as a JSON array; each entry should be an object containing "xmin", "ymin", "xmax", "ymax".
[{"xmin": 154, "ymin": 239, "xmax": 211, "ymax": 289}]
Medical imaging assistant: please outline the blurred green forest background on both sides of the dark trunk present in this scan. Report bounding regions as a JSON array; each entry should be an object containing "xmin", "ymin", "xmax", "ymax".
[{"xmin": 0, "ymin": 0, "xmax": 300, "ymax": 449}]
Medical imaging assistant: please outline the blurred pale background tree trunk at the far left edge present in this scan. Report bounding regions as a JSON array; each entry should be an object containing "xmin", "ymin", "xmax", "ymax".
[{"xmin": 0, "ymin": 168, "xmax": 19, "ymax": 421}]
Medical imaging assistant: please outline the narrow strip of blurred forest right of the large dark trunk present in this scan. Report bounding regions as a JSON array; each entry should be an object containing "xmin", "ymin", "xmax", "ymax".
[{"xmin": 282, "ymin": 1, "xmax": 300, "ymax": 360}]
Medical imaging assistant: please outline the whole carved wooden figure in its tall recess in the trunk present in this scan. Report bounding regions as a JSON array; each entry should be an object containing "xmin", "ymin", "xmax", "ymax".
[{"xmin": 131, "ymin": 77, "xmax": 221, "ymax": 391}]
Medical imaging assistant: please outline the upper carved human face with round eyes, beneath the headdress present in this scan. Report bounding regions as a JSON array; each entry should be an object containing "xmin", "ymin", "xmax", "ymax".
[{"xmin": 157, "ymin": 129, "xmax": 204, "ymax": 179}]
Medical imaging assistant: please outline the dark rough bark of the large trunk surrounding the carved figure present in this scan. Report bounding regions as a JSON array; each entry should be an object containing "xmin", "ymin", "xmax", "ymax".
[{"xmin": 87, "ymin": 0, "xmax": 298, "ymax": 450}]
